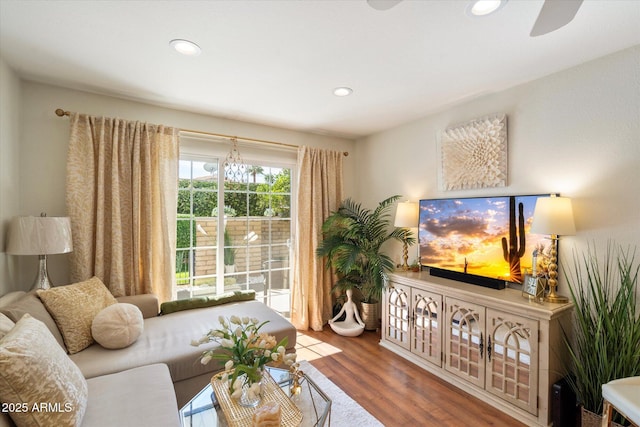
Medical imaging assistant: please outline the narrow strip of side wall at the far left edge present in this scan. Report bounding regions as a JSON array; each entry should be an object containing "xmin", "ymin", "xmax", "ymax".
[{"xmin": 0, "ymin": 58, "xmax": 21, "ymax": 295}]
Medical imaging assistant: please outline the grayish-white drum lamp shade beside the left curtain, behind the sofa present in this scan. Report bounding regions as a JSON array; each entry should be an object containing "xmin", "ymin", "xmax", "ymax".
[{"xmin": 7, "ymin": 216, "xmax": 73, "ymax": 255}]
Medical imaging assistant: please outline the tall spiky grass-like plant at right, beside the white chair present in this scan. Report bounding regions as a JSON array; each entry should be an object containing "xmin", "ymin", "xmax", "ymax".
[{"xmin": 565, "ymin": 244, "xmax": 640, "ymax": 426}]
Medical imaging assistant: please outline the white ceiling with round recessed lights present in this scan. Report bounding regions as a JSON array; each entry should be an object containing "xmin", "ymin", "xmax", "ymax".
[{"xmin": 0, "ymin": 0, "xmax": 640, "ymax": 139}]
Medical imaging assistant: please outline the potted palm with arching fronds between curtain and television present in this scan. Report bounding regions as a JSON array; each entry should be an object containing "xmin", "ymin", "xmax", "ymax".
[{"xmin": 316, "ymin": 195, "xmax": 415, "ymax": 330}]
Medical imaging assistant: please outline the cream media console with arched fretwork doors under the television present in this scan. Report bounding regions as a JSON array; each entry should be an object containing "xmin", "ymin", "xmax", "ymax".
[{"xmin": 380, "ymin": 271, "xmax": 573, "ymax": 426}]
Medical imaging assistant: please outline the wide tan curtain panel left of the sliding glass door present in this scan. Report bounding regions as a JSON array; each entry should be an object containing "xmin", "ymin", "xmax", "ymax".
[{"xmin": 66, "ymin": 113, "xmax": 179, "ymax": 301}]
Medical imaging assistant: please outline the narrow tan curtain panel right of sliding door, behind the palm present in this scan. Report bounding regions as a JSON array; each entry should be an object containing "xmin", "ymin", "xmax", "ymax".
[{"xmin": 291, "ymin": 147, "xmax": 344, "ymax": 331}]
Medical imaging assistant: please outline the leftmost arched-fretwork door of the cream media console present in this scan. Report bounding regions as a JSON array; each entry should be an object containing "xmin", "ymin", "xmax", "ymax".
[{"xmin": 383, "ymin": 282, "xmax": 411, "ymax": 350}]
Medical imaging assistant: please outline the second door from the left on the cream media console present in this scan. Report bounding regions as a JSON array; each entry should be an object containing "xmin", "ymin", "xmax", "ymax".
[{"xmin": 411, "ymin": 288, "xmax": 442, "ymax": 366}]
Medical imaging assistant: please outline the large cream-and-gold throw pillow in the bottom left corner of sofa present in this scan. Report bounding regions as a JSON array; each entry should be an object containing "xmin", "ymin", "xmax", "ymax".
[{"xmin": 0, "ymin": 314, "xmax": 88, "ymax": 427}]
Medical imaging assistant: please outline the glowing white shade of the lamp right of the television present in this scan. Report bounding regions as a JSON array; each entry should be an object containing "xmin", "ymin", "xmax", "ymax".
[{"xmin": 531, "ymin": 197, "xmax": 576, "ymax": 236}]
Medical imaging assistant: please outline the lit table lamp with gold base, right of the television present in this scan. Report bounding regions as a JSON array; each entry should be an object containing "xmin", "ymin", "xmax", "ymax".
[{"xmin": 531, "ymin": 196, "xmax": 576, "ymax": 303}]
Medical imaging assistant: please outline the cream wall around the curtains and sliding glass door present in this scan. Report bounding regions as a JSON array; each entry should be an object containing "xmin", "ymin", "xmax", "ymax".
[{"xmin": 0, "ymin": 81, "xmax": 355, "ymax": 295}]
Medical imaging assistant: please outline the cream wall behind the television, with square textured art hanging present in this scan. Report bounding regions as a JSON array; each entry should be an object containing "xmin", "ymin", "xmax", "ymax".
[{"xmin": 356, "ymin": 46, "xmax": 640, "ymax": 280}]
